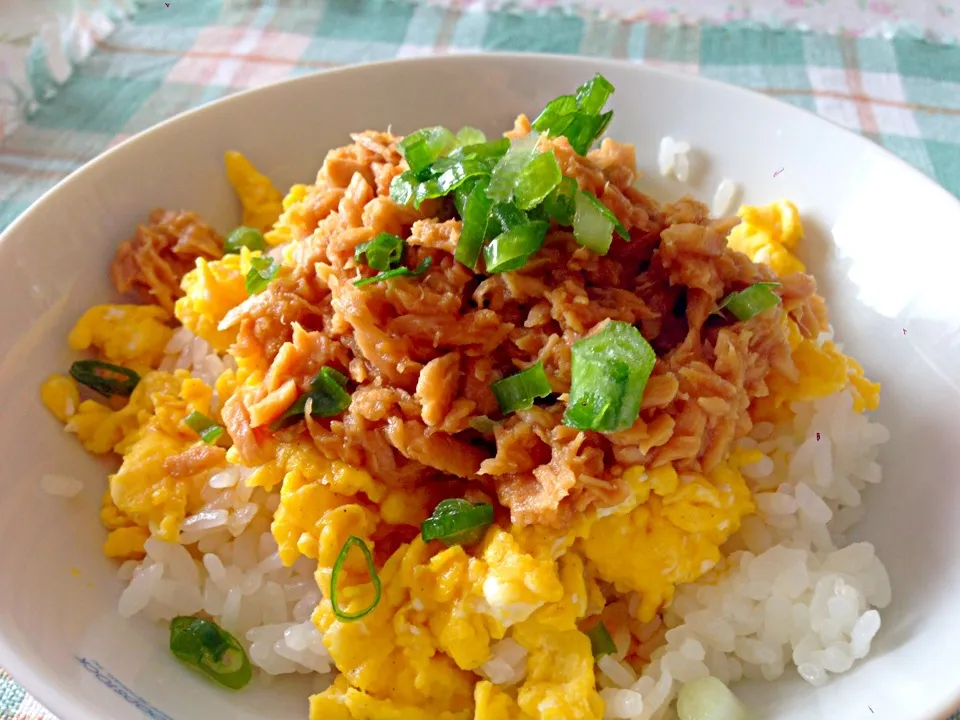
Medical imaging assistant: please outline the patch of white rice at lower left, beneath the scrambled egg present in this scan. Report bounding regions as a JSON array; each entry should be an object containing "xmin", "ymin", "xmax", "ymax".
[{"xmin": 118, "ymin": 462, "xmax": 331, "ymax": 675}]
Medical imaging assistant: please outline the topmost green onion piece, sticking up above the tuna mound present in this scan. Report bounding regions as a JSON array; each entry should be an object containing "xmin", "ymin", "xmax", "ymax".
[{"xmin": 532, "ymin": 73, "xmax": 614, "ymax": 155}]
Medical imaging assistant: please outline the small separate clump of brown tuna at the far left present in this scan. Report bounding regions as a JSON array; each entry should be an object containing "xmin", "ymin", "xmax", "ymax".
[{"xmin": 110, "ymin": 210, "xmax": 223, "ymax": 313}]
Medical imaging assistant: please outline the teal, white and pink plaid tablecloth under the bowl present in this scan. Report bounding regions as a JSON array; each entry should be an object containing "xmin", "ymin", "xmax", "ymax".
[{"xmin": 0, "ymin": 0, "xmax": 960, "ymax": 720}]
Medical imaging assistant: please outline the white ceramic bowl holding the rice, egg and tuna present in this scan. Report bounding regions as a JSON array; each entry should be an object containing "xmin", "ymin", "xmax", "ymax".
[{"xmin": 0, "ymin": 55, "xmax": 960, "ymax": 720}]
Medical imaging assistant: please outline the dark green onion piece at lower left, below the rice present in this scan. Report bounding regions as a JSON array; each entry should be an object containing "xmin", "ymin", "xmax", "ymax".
[{"xmin": 170, "ymin": 615, "xmax": 253, "ymax": 690}]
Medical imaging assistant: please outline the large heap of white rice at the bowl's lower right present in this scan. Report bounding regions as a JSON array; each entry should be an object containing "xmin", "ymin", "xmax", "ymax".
[{"xmin": 598, "ymin": 391, "xmax": 890, "ymax": 720}]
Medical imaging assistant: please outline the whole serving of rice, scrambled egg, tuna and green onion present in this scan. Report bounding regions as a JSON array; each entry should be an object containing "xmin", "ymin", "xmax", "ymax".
[{"xmin": 41, "ymin": 78, "xmax": 891, "ymax": 720}]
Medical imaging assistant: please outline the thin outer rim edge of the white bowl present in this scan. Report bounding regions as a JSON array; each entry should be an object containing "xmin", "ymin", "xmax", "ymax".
[{"xmin": 0, "ymin": 52, "xmax": 960, "ymax": 720}]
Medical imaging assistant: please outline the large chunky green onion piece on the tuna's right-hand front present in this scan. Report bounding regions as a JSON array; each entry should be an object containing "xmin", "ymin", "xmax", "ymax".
[{"xmin": 563, "ymin": 320, "xmax": 657, "ymax": 432}]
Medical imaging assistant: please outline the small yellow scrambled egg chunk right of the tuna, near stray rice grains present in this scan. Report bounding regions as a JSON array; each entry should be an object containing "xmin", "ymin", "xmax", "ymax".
[{"xmin": 727, "ymin": 200, "xmax": 806, "ymax": 275}]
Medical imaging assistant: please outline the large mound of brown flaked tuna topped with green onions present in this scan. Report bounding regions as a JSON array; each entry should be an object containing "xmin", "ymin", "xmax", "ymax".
[{"xmin": 216, "ymin": 116, "xmax": 827, "ymax": 525}]
